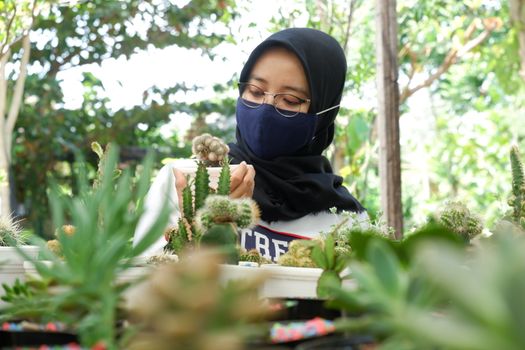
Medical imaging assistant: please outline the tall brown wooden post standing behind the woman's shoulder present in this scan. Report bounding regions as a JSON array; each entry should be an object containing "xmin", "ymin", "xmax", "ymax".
[{"xmin": 376, "ymin": 0, "xmax": 403, "ymax": 238}]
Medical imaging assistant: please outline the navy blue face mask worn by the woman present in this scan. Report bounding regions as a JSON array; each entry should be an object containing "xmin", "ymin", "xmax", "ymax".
[{"xmin": 236, "ymin": 99, "xmax": 317, "ymax": 160}]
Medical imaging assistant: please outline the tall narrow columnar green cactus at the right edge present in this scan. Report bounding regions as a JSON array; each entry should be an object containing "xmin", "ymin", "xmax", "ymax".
[{"xmin": 508, "ymin": 145, "xmax": 525, "ymax": 229}]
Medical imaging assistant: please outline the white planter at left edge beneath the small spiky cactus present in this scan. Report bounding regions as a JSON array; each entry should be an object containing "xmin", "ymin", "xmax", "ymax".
[{"xmin": 0, "ymin": 245, "xmax": 40, "ymax": 305}]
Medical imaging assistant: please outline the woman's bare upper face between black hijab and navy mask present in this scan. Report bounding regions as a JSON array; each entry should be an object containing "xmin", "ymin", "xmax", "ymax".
[{"xmin": 248, "ymin": 47, "xmax": 310, "ymax": 113}]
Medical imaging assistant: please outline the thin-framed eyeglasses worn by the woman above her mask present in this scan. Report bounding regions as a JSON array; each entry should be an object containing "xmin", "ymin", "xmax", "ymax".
[{"xmin": 238, "ymin": 83, "xmax": 339, "ymax": 118}]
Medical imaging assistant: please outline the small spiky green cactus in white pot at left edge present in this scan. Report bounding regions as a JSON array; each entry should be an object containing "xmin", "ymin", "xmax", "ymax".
[{"xmin": 0, "ymin": 216, "xmax": 39, "ymax": 303}]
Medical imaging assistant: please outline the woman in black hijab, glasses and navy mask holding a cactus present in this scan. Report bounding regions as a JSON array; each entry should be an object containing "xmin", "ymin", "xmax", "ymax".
[{"xmin": 133, "ymin": 28, "xmax": 367, "ymax": 261}]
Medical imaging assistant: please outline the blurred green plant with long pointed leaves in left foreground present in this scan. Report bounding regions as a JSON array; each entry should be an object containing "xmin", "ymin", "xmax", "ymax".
[{"xmin": 2, "ymin": 147, "xmax": 168, "ymax": 349}]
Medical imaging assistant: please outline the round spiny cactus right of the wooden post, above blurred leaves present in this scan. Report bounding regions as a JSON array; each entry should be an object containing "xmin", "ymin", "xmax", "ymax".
[{"xmin": 438, "ymin": 202, "xmax": 483, "ymax": 242}]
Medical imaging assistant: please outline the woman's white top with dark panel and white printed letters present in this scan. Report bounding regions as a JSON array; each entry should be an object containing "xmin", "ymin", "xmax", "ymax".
[{"xmin": 133, "ymin": 162, "xmax": 368, "ymax": 261}]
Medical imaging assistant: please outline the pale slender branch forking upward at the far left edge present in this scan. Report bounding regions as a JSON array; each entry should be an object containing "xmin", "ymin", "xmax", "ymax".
[{"xmin": 4, "ymin": 33, "xmax": 31, "ymax": 163}]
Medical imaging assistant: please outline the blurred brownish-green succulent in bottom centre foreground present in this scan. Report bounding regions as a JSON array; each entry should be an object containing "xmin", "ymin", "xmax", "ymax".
[{"xmin": 126, "ymin": 249, "xmax": 268, "ymax": 350}]
